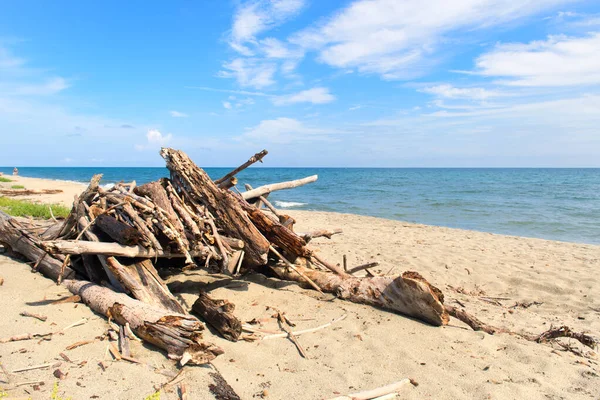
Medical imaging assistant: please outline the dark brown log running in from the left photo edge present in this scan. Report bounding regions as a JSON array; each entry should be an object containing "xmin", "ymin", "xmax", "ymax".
[{"xmin": 0, "ymin": 211, "xmax": 75, "ymax": 280}]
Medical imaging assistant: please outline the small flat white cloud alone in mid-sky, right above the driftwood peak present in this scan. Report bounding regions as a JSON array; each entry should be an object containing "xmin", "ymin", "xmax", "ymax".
[{"xmin": 241, "ymin": 117, "xmax": 341, "ymax": 144}]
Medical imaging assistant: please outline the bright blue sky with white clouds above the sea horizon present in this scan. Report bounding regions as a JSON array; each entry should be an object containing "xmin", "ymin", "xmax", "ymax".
[{"xmin": 0, "ymin": 0, "xmax": 600, "ymax": 167}]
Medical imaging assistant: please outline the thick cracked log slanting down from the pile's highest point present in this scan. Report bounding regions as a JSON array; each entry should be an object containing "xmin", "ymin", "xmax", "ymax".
[{"xmin": 161, "ymin": 148, "xmax": 269, "ymax": 267}]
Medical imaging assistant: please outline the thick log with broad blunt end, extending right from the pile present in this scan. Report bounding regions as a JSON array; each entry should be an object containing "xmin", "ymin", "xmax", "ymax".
[{"xmin": 271, "ymin": 266, "xmax": 448, "ymax": 326}]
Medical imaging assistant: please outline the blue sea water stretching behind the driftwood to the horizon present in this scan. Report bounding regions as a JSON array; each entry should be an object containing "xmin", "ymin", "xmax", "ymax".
[{"xmin": 0, "ymin": 167, "xmax": 600, "ymax": 244}]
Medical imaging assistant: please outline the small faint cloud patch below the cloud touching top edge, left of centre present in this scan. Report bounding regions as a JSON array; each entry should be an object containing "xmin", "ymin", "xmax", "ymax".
[{"xmin": 218, "ymin": 58, "xmax": 277, "ymax": 89}]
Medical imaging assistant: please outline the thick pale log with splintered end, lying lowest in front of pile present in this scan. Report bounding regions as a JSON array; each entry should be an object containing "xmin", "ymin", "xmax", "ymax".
[{"xmin": 63, "ymin": 280, "xmax": 223, "ymax": 365}]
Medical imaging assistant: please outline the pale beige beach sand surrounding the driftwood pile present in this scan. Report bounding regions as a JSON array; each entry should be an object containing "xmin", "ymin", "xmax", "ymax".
[{"xmin": 0, "ymin": 178, "xmax": 600, "ymax": 399}]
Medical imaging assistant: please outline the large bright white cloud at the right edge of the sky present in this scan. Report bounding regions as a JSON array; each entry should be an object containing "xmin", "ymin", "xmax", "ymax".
[{"xmin": 476, "ymin": 33, "xmax": 600, "ymax": 86}]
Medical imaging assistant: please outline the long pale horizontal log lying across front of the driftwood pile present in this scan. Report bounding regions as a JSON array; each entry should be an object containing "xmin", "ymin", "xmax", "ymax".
[{"xmin": 42, "ymin": 240, "xmax": 210, "ymax": 258}]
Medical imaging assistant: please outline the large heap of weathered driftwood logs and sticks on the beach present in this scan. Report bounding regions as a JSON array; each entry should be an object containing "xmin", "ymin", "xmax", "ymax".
[{"xmin": 0, "ymin": 148, "xmax": 592, "ymax": 365}]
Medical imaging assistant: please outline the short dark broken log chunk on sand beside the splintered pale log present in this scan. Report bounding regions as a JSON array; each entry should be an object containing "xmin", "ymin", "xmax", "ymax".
[{"xmin": 192, "ymin": 292, "xmax": 242, "ymax": 342}]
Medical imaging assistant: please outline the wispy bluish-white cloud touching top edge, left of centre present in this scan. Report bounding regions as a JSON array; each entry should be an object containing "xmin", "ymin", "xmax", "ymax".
[{"xmin": 230, "ymin": 0, "xmax": 305, "ymax": 51}]
